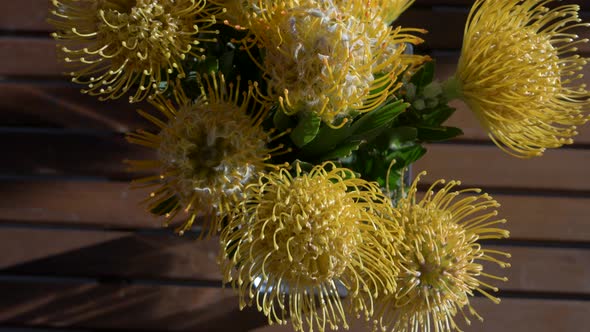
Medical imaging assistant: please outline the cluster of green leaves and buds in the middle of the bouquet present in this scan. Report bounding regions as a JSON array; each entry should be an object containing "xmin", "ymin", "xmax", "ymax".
[{"xmin": 272, "ymin": 63, "xmax": 462, "ymax": 197}]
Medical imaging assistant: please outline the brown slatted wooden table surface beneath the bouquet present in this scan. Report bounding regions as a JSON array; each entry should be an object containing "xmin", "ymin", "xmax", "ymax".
[{"xmin": 0, "ymin": 0, "xmax": 590, "ymax": 332}]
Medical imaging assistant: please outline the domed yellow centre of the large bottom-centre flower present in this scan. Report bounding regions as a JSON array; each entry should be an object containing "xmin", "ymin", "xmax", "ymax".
[{"xmin": 258, "ymin": 175, "xmax": 361, "ymax": 286}]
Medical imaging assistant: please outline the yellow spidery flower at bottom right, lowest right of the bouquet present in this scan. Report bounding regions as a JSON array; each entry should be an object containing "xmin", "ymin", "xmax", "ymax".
[{"xmin": 373, "ymin": 172, "xmax": 510, "ymax": 332}]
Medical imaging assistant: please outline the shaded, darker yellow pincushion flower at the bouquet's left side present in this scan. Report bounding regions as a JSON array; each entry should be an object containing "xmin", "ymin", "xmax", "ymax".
[{"xmin": 127, "ymin": 75, "xmax": 285, "ymax": 235}]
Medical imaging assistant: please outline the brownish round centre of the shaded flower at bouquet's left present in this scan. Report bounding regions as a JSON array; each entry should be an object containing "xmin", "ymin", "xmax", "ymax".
[{"xmin": 158, "ymin": 101, "xmax": 266, "ymax": 206}]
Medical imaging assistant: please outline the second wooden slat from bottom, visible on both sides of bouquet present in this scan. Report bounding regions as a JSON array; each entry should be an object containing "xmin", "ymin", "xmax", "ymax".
[{"xmin": 0, "ymin": 228, "xmax": 590, "ymax": 294}]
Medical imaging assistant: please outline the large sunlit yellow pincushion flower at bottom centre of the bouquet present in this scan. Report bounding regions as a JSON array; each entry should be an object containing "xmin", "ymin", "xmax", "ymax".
[{"xmin": 221, "ymin": 163, "xmax": 402, "ymax": 331}]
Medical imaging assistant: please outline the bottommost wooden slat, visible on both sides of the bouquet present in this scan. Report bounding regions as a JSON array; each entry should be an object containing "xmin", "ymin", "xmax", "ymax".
[{"xmin": 0, "ymin": 282, "xmax": 590, "ymax": 332}]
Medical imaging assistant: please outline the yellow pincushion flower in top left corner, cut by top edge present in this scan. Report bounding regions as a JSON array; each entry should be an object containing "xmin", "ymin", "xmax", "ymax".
[{"xmin": 49, "ymin": 0, "xmax": 222, "ymax": 102}]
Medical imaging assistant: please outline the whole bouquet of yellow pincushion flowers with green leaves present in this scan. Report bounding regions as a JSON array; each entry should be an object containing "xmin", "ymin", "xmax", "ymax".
[{"xmin": 50, "ymin": 0, "xmax": 590, "ymax": 332}]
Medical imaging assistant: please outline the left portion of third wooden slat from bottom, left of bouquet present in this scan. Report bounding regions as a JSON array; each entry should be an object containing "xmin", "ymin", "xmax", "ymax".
[{"xmin": 0, "ymin": 180, "xmax": 156, "ymax": 228}]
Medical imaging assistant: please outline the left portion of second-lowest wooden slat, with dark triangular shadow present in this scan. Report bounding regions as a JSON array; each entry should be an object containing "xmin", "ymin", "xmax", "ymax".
[{"xmin": 0, "ymin": 227, "xmax": 221, "ymax": 286}]
